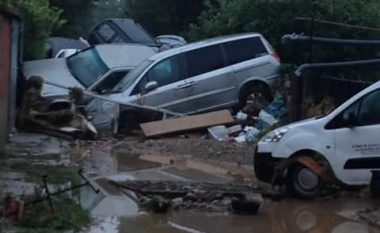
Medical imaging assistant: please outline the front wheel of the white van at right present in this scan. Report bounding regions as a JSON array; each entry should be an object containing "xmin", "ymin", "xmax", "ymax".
[{"xmin": 286, "ymin": 164, "xmax": 324, "ymax": 198}]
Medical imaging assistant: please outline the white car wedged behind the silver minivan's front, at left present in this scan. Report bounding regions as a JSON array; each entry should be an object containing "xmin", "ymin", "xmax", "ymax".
[{"xmin": 23, "ymin": 44, "xmax": 156, "ymax": 98}]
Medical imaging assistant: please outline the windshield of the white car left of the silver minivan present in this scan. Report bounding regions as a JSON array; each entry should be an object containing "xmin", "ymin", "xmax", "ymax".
[{"xmin": 66, "ymin": 48, "xmax": 109, "ymax": 88}]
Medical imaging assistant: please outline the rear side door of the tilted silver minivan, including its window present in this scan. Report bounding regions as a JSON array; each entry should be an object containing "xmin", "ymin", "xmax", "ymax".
[{"xmin": 184, "ymin": 45, "xmax": 237, "ymax": 113}]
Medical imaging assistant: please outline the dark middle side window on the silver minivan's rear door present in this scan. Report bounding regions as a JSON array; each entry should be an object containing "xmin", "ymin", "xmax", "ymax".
[{"xmin": 184, "ymin": 45, "xmax": 226, "ymax": 77}]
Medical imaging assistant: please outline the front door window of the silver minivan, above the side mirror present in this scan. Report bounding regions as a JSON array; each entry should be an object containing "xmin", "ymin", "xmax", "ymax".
[{"xmin": 133, "ymin": 55, "xmax": 183, "ymax": 94}]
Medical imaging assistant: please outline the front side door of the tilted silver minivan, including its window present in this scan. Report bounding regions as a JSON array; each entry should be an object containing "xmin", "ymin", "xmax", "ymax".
[{"xmin": 132, "ymin": 55, "xmax": 188, "ymax": 113}]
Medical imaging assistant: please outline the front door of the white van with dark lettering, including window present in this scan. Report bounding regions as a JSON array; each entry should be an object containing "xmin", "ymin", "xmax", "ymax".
[{"xmin": 334, "ymin": 90, "xmax": 380, "ymax": 185}]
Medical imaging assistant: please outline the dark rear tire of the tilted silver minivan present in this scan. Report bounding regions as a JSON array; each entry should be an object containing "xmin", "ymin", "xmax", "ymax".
[{"xmin": 239, "ymin": 82, "xmax": 273, "ymax": 108}]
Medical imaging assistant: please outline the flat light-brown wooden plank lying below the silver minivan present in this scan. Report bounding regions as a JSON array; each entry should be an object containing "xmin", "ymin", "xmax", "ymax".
[{"xmin": 140, "ymin": 110, "xmax": 234, "ymax": 137}]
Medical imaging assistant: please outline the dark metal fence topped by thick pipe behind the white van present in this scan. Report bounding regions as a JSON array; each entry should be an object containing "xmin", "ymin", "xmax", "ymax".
[{"xmin": 290, "ymin": 59, "xmax": 380, "ymax": 121}]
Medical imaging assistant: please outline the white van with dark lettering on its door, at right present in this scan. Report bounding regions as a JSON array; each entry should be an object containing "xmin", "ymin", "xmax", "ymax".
[{"xmin": 254, "ymin": 82, "xmax": 380, "ymax": 197}]
